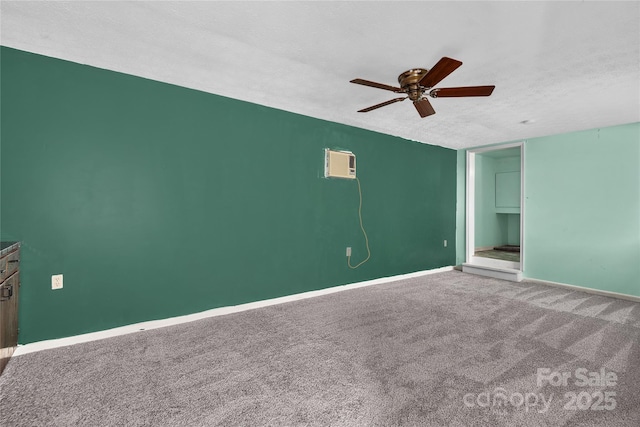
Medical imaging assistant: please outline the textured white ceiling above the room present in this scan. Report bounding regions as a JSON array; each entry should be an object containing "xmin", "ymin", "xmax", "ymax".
[{"xmin": 0, "ymin": 1, "xmax": 640, "ymax": 148}]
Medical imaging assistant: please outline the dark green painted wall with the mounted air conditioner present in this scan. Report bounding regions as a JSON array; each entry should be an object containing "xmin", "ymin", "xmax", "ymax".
[{"xmin": 0, "ymin": 47, "xmax": 456, "ymax": 343}]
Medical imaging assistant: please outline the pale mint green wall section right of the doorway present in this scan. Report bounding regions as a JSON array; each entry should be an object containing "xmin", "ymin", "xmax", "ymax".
[{"xmin": 524, "ymin": 123, "xmax": 640, "ymax": 296}]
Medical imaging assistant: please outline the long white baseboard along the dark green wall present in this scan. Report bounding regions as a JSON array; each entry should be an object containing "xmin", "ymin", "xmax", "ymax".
[{"xmin": 13, "ymin": 266, "xmax": 453, "ymax": 357}]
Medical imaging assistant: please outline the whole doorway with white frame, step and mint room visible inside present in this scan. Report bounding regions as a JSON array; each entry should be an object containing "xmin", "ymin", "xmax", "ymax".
[{"xmin": 463, "ymin": 142, "xmax": 524, "ymax": 281}]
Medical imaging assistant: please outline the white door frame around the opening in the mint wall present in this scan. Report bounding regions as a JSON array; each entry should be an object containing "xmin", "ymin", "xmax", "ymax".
[{"xmin": 465, "ymin": 141, "xmax": 525, "ymax": 272}]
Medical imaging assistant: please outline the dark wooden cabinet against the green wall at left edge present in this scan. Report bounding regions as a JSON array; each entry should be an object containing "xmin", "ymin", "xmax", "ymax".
[{"xmin": 0, "ymin": 242, "xmax": 20, "ymax": 374}]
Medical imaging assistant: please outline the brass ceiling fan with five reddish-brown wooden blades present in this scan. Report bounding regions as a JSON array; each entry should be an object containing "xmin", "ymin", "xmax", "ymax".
[{"xmin": 351, "ymin": 56, "xmax": 495, "ymax": 117}]
